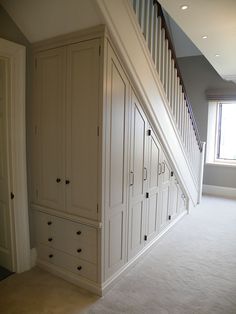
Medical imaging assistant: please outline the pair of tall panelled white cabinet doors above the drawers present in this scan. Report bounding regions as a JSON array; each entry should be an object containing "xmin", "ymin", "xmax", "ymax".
[{"xmin": 31, "ymin": 39, "xmax": 100, "ymax": 219}]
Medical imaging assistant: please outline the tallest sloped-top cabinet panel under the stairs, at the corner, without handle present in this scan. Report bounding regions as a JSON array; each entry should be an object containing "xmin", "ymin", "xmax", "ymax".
[{"xmin": 104, "ymin": 42, "xmax": 130, "ymax": 279}]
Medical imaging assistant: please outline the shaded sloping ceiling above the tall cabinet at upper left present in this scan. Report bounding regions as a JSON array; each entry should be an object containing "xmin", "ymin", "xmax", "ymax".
[{"xmin": 0, "ymin": 0, "xmax": 102, "ymax": 43}]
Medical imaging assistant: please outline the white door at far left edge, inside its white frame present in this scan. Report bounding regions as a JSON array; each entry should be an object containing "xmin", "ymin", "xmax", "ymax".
[{"xmin": 0, "ymin": 58, "xmax": 12, "ymax": 270}]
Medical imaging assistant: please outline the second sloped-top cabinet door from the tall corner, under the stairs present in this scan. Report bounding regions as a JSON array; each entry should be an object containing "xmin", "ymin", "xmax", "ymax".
[{"xmin": 128, "ymin": 93, "xmax": 148, "ymax": 259}]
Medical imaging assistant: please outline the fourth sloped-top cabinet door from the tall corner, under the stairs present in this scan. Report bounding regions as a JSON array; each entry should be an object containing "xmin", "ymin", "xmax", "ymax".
[{"xmin": 159, "ymin": 152, "xmax": 171, "ymax": 230}]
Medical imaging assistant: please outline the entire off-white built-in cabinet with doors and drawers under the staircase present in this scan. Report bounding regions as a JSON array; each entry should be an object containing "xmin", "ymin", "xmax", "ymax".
[{"xmin": 29, "ymin": 27, "xmax": 186, "ymax": 293}]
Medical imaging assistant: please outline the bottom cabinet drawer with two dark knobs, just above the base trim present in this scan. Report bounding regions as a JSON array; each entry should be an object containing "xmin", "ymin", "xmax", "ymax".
[{"xmin": 38, "ymin": 245, "xmax": 97, "ymax": 281}]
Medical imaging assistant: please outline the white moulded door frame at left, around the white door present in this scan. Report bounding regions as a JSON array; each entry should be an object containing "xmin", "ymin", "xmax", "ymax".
[{"xmin": 0, "ymin": 38, "xmax": 31, "ymax": 273}]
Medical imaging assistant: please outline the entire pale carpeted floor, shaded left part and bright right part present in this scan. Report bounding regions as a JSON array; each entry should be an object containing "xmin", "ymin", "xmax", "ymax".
[{"xmin": 0, "ymin": 197, "xmax": 236, "ymax": 314}]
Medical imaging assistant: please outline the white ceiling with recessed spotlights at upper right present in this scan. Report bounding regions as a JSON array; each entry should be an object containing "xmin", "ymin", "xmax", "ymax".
[{"xmin": 159, "ymin": 0, "xmax": 236, "ymax": 81}]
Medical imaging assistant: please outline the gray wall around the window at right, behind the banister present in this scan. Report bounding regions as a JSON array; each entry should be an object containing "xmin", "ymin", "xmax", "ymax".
[{"xmin": 178, "ymin": 56, "xmax": 236, "ymax": 188}]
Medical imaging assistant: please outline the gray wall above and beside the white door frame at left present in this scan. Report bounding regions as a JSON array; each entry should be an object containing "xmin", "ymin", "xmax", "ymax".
[{"xmin": 0, "ymin": 5, "xmax": 34, "ymax": 246}]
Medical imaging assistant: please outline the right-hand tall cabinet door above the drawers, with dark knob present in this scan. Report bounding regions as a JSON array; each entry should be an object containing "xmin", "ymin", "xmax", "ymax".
[{"xmin": 66, "ymin": 40, "xmax": 100, "ymax": 219}]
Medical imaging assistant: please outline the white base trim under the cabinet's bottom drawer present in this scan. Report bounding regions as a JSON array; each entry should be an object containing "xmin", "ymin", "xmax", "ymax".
[{"xmin": 37, "ymin": 260, "xmax": 102, "ymax": 296}]
